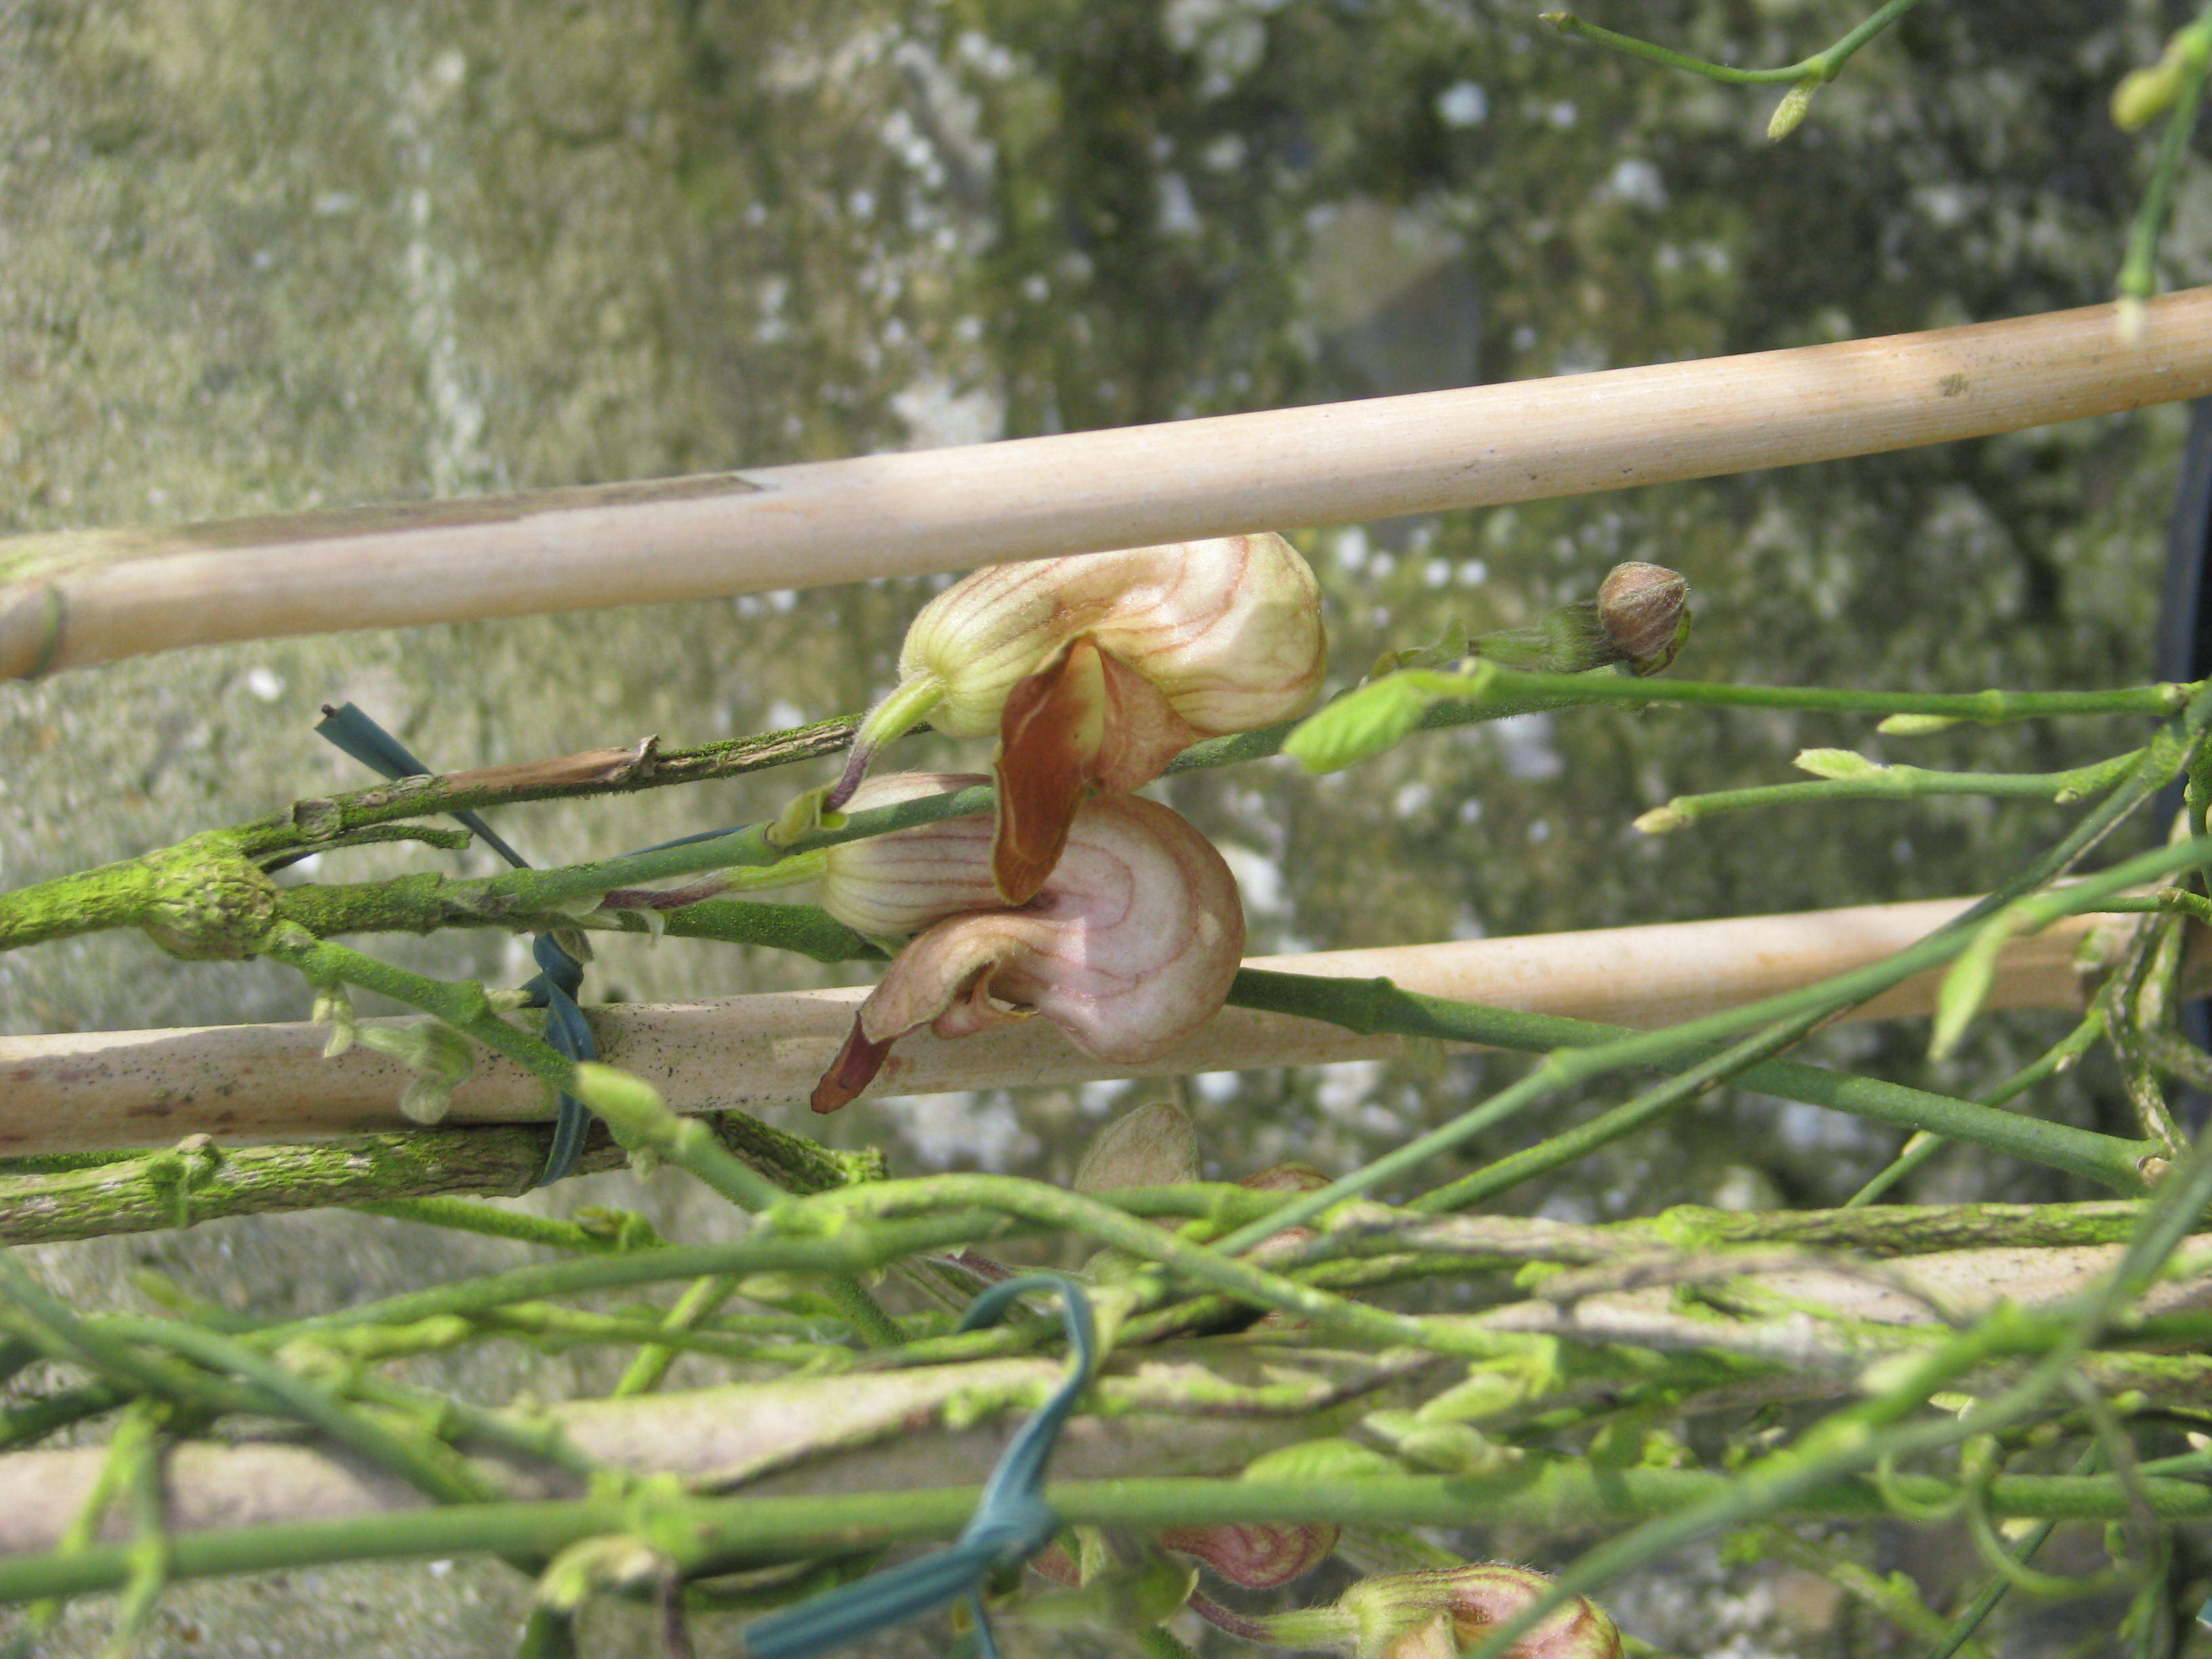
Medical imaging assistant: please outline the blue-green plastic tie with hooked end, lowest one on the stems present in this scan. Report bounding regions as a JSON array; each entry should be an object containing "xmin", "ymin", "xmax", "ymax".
[{"xmin": 743, "ymin": 1274, "xmax": 1099, "ymax": 1659}]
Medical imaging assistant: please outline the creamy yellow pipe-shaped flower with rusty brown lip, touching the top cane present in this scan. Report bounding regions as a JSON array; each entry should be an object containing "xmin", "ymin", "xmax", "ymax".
[{"xmin": 825, "ymin": 533, "xmax": 1325, "ymax": 905}]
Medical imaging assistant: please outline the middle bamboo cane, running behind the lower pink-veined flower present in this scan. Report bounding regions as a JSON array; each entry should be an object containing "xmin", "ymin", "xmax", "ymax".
[{"xmin": 0, "ymin": 898, "xmax": 2095, "ymax": 1155}]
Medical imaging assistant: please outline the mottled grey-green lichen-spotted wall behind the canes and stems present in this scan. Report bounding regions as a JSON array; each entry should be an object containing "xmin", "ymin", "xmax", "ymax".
[{"xmin": 0, "ymin": 0, "xmax": 2212, "ymax": 1654}]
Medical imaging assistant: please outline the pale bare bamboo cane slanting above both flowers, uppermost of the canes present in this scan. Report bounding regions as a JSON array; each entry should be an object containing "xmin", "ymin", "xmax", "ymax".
[{"xmin": 0, "ymin": 287, "xmax": 2212, "ymax": 679}]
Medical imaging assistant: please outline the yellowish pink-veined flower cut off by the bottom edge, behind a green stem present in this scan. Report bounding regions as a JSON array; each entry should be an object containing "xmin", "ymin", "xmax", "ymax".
[{"xmin": 1336, "ymin": 1561, "xmax": 1622, "ymax": 1659}]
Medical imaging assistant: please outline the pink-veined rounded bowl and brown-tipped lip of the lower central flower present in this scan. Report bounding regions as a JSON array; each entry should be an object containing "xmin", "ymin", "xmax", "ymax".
[{"xmin": 814, "ymin": 796, "xmax": 1246, "ymax": 1113}]
